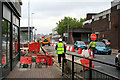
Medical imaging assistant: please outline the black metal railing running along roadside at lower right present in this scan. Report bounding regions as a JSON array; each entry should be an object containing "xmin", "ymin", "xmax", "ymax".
[{"xmin": 62, "ymin": 53, "xmax": 120, "ymax": 80}]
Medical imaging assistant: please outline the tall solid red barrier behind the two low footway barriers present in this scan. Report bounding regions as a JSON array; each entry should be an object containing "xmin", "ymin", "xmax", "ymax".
[{"xmin": 29, "ymin": 42, "xmax": 40, "ymax": 52}]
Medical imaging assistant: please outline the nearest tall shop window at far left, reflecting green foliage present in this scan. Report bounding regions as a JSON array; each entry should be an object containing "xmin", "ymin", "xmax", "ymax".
[{"xmin": 2, "ymin": 20, "xmax": 10, "ymax": 66}]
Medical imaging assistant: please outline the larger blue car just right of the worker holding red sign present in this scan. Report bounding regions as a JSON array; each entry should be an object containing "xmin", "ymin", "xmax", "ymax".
[{"xmin": 95, "ymin": 42, "xmax": 111, "ymax": 55}]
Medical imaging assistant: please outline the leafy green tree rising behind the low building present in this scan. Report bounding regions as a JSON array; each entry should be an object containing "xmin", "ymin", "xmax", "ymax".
[{"xmin": 57, "ymin": 17, "xmax": 86, "ymax": 35}]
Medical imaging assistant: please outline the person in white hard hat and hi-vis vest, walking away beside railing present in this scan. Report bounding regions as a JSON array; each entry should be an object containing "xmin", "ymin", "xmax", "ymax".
[{"xmin": 55, "ymin": 38, "xmax": 66, "ymax": 67}]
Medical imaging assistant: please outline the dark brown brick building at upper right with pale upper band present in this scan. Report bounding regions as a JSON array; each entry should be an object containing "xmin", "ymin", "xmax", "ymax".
[{"xmin": 83, "ymin": 0, "xmax": 120, "ymax": 49}]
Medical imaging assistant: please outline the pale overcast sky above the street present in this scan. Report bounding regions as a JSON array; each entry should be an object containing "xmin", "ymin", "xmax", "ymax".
[{"xmin": 21, "ymin": 0, "xmax": 112, "ymax": 34}]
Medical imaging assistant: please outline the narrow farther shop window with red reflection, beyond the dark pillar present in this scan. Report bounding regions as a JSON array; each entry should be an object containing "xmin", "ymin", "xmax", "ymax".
[{"xmin": 13, "ymin": 25, "xmax": 18, "ymax": 58}]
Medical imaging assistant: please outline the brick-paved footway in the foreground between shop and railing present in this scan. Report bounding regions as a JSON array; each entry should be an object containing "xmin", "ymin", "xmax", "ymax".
[{"xmin": 6, "ymin": 63, "xmax": 64, "ymax": 80}]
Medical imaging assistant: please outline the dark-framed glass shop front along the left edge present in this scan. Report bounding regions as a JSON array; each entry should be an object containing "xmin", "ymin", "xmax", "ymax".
[{"xmin": 0, "ymin": 1, "xmax": 21, "ymax": 78}]
